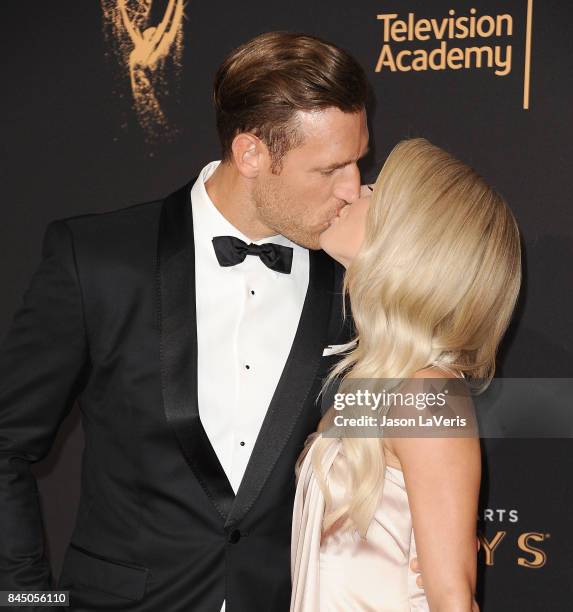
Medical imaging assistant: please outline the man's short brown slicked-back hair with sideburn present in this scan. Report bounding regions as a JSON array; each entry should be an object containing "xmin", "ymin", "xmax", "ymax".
[{"xmin": 213, "ymin": 32, "xmax": 369, "ymax": 172}]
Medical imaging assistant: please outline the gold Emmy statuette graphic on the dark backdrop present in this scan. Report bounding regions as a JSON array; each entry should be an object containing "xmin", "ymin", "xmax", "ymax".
[{"xmin": 102, "ymin": 0, "xmax": 184, "ymax": 141}]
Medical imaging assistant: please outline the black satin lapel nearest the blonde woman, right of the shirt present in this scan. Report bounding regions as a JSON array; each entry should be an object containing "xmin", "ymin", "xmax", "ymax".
[{"xmin": 225, "ymin": 251, "xmax": 334, "ymax": 527}]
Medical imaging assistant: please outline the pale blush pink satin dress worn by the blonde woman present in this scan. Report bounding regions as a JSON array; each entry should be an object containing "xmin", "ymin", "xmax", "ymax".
[{"xmin": 290, "ymin": 437, "xmax": 430, "ymax": 612}]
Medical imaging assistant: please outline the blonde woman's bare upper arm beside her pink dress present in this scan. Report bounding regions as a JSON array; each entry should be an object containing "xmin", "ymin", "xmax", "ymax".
[{"xmin": 386, "ymin": 369, "xmax": 481, "ymax": 612}]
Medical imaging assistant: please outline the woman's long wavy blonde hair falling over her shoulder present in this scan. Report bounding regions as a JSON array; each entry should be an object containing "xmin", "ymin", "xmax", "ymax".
[{"xmin": 302, "ymin": 138, "xmax": 521, "ymax": 538}]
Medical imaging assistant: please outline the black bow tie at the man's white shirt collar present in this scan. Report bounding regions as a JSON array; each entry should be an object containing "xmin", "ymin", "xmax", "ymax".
[{"xmin": 213, "ymin": 236, "xmax": 293, "ymax": 274}]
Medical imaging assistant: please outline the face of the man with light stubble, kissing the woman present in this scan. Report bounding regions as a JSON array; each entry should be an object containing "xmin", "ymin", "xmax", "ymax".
[{"xmin": 253, "ymin": 108, "xmax": 368, "ymax": 249}]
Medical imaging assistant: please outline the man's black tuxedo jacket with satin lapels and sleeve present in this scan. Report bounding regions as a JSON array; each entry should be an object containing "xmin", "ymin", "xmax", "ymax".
[{"xmin": 0, "ymin": 181, "xmax": 352, "ymax": 612}]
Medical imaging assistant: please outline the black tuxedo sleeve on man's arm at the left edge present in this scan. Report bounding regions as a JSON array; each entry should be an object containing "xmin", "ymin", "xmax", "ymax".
[{"xmin": 0, "ymin": 220, "xmax": 89, "ymax": 590}]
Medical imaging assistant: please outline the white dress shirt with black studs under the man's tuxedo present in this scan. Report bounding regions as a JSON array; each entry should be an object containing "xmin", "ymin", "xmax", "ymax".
[{"xmin": 191, "ymin": 161, "xmax": 309, "ymax": 612}]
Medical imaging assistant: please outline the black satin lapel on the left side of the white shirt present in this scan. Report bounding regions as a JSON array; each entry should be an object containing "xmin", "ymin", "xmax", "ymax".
[{"xmin": 157, "ymin": 181, "xmax": 235, "ymax": 520}]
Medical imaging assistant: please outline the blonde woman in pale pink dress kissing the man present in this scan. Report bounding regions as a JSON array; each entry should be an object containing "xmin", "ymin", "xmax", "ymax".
[{"xmin": 291, "ymin": 138, "xmax": 521, "ymax": 612}]
